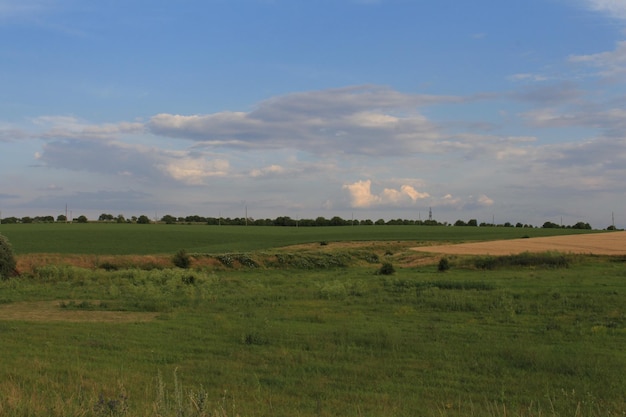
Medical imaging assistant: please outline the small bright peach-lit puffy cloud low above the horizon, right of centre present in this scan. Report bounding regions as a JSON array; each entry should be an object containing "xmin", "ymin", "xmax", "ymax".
[{"xmin": 343, "ymin": 180, "xmax": 430, "ymax": 208}]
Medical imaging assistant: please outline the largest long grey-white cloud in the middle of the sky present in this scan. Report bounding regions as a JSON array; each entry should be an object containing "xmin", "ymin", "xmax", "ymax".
[{"xmin": 148, "ymin": 86, "xmax": 465, "ymax": 156}]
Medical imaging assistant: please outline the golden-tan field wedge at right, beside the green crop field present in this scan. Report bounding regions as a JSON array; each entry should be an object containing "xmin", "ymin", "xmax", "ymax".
[{"xmin": 412, "ymin": 232, "xmax": 626, "ymax": 255}]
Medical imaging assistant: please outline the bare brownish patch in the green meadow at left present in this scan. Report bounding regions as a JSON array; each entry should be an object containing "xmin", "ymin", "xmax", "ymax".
[{"xmin": 0, "ymin": 301, "xmax": 159, "ymax": 323}]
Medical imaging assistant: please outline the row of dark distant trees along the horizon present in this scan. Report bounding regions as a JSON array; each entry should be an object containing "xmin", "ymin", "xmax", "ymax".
[{"xmin": 0, "ymin": 213, "xmax": 596, "ymax": 230}]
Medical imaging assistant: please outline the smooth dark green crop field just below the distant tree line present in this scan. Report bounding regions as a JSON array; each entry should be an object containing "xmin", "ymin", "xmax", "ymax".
[{"xmin": 0, "ymin": 223, "xmax": 591, "ymax": 255}]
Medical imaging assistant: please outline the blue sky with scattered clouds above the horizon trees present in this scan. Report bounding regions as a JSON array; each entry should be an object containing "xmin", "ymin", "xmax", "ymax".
[{"xmin": 0, "ymin": 0, "xmax": 626, "ymax": 229}]
